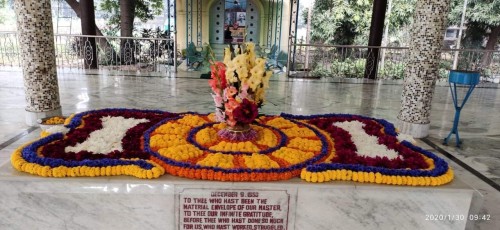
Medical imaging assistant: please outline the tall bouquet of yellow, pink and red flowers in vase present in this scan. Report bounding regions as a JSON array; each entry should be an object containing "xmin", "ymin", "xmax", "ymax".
[{"xmin": 209, "ymin": 43, "xmax": 272, "ymax": 141}]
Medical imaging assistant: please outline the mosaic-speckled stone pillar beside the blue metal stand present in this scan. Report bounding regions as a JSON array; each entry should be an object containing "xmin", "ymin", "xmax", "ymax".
[{"xmin": 397, "ymin": 0, "xmax": 450, "ymax": 138}]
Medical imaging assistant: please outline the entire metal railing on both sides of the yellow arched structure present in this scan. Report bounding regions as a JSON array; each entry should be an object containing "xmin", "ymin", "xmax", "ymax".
[{"xmin": 0, "ymin": 32, "xmax": 500, "ymax": 81}]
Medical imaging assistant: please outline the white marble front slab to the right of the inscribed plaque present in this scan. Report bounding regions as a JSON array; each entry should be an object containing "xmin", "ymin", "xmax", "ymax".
[{"xmin": 295, "ymin": 186, "xmax": 472, "ymax": 230}]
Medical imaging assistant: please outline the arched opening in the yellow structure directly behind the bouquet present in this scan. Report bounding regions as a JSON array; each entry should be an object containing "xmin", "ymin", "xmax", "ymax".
[{"xmin": 209, "ymin": 0, "xmax": 260, "ymax": 44}]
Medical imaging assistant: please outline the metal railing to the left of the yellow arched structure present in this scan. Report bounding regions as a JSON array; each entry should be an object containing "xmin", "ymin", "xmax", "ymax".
[{"xmin": 0, "ymin": 32, "xmax": 180, "ymax": 72}]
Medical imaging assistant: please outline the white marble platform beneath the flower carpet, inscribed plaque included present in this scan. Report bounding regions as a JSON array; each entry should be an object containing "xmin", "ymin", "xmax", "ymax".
[{"xmin": 0, "ymin": 162, "xmax": 481, "ymax": 230}]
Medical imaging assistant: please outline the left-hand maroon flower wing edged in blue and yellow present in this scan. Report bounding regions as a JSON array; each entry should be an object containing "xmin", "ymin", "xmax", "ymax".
[{"xmin": 11, "ymin": 109, "xmax": 177, "ymax": 179}]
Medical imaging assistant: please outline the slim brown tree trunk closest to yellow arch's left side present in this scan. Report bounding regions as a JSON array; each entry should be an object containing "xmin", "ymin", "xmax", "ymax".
[{"xmin": 120, "ymin": 0, "xmax": 135, "ymax": 64}]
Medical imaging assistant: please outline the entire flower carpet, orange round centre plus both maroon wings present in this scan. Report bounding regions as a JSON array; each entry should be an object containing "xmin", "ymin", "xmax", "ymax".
[{"xmin": 11, "ymin": 109, "xmax": 453, "ymax": 186}]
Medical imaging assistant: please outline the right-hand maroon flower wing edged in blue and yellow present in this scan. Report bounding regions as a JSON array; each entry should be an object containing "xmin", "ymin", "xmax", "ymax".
[{"xmin": 282, "ymin": 114, "xmax": 453, "ymax": 186}]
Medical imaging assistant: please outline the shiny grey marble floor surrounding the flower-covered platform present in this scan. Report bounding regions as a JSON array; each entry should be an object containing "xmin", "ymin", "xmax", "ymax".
[{"xmin": 0, "ymin": 68, "xmax": 500, "ymax": 229}]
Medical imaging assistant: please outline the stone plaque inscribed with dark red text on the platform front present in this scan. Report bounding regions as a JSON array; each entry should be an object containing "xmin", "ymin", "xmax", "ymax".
[{"xmin": 178, "ymin": 188, "xmax": 290, "ymax": 230}]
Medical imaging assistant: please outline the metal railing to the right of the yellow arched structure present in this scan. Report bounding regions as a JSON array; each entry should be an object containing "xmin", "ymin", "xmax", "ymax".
[{"xmin": 289, "ymin": 44, "xmax": 500, "ymax": 81}]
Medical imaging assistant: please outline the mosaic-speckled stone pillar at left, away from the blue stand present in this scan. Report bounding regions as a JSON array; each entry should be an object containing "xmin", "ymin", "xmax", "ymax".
[{"xmin": 14, "ymin": 0, "xmax": 61, "ymax": 126}]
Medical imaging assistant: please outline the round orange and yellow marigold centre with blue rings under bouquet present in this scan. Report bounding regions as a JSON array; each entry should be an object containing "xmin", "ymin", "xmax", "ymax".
[{"xmin": 144, "ymin": 114, "xmax": 333, "ymax": 181}]
